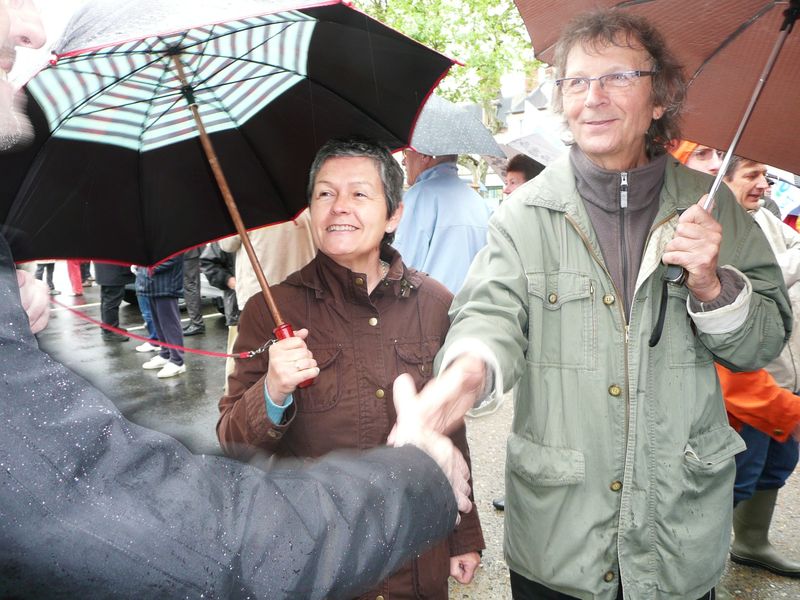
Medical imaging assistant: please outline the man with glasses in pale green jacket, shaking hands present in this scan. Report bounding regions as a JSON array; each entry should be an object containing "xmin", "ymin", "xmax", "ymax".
[{"xmin": 432, "ymin": 11, "xmax": 791, "ymax": 600}]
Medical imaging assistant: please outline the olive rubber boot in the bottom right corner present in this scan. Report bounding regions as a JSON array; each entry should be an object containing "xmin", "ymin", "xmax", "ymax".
[{"xmin": 731, "ymin": 489, "xmax": 800, "ymax": 578}]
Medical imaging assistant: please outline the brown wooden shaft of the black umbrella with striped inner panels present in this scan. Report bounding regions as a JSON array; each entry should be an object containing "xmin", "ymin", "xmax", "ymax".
[{"xmin": 172, "ymin": 54, "xmax": 292, "ymax": 328}]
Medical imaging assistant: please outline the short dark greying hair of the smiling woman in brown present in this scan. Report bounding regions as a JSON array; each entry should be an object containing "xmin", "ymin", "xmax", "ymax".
[{"xmin": 306, "ymin": 137, "xmax": 403, "ymax": 244}]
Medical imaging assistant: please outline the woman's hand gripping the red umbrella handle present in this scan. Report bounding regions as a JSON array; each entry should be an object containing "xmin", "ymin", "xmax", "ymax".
[{"xmin": 267, "ymin": 329, "xmax": 319, "ymax": 406}]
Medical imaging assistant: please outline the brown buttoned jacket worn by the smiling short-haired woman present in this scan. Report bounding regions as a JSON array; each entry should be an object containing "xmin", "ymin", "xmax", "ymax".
[{"xmin": 217, "ymin": 247, "xmax": 484, "ymax": 600}]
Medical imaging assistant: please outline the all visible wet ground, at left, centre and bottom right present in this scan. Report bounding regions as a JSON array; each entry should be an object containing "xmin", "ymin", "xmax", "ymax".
[{"xmin": 39, "ymin": 264, "xmax": 800, "ymax": 600}]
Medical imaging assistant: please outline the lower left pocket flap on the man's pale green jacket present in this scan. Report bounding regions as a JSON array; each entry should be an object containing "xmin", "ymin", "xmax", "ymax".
[{"xmin": 506, "ymin": 433, "xmax": 586, "ymax": 487}]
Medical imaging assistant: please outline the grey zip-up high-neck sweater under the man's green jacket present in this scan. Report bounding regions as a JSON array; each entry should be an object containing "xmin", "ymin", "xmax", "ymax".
[{"xmin": 569, "ymin": 145, "xmax": 667, "ymax": 315}]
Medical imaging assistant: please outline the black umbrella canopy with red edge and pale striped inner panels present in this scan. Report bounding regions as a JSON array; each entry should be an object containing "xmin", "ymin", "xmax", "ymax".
[{"xmin": 0, "ymin": 0, "xmax": 452, "ymax": 265}]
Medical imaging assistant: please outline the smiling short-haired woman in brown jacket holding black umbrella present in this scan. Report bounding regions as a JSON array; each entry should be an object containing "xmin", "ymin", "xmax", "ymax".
[{"xmin": 217, "ymin": 140, "xmax": 484, "ymax": 600}]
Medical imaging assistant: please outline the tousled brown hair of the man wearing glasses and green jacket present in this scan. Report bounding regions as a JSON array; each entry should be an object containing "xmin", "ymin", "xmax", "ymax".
[{"xmin": 553, "ymin": 9, "xmax": 686, "ymax": 156}]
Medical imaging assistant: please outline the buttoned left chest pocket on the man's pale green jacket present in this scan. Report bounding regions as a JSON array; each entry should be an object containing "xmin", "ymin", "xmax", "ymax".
[{"xmin": 526, "ymin": 271, "xmax": 597, "ymax": 370}]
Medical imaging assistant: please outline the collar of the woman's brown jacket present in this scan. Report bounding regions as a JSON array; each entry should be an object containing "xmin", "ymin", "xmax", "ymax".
[{"xmin": 286, "ymin": 244, "xmax": 423, "ymax": 301}]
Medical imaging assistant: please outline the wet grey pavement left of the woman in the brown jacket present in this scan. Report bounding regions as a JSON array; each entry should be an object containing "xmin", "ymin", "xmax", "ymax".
[{"xmin": 39, "ymin": 274, "xmax": 228, "ymax": 454}]
